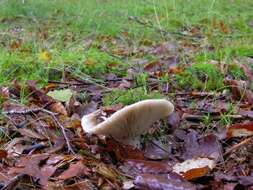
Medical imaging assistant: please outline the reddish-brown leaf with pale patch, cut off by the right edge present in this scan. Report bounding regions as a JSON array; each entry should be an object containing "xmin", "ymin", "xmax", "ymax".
[{"xmin": 227, "ymin": 122, "xmax": 253, "ymax": 138}]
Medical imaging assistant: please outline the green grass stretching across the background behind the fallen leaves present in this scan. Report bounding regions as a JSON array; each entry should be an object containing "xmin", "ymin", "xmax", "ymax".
[{"xmin": 0, "ymin": 0, "xmax": 253, "ymax": 89}]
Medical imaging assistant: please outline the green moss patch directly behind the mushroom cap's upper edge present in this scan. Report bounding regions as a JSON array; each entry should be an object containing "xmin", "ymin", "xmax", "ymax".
[{"xmin": 103, "ymin": 88, "xmax": 162, "ymax": 106}]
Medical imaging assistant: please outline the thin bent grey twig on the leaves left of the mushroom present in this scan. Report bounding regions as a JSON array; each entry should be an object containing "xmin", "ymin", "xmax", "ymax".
[{"xmin": 3, "ymin": 108, "xmax": 75, "ymax": 154}]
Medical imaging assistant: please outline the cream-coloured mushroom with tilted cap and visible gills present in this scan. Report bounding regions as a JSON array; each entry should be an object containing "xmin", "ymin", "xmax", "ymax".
[{"xmin": 81, "ymin": 99, "xmax": 174, "ymax": 146}]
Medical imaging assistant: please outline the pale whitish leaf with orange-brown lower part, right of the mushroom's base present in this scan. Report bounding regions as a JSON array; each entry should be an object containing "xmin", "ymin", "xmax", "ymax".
[{"xmin": 173, "ymin": 157, "xmax": 215, "ymax": 180}]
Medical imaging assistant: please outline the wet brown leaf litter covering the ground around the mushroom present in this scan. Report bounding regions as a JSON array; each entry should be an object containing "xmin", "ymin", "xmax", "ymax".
[{"xmin": 0, "ymin": 32, "xmax": 253, "ymax": 190}]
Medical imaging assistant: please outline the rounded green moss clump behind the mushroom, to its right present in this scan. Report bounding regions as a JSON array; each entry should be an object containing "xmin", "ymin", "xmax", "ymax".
[{"xmin": 176, "ymin": 63, "xmax": 224, "ymax": 91}]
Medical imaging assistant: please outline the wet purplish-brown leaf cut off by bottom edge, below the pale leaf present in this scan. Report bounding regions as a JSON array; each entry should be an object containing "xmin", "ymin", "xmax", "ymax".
[{"xmin": 134, "ymin": 173, "xmax": 196, "ymax": 190}]
